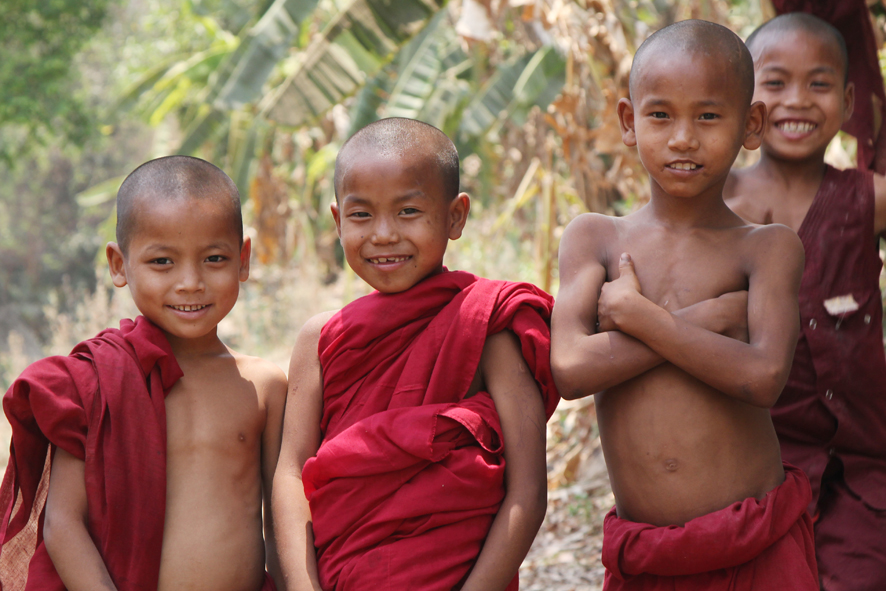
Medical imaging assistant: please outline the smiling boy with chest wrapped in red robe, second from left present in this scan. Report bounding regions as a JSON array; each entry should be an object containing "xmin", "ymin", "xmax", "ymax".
[{"xmin": 273, "ymin": 118, "xmax": 558, "ymax": 591}]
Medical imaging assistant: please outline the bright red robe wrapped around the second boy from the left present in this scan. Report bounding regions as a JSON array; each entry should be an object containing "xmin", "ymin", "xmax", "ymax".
[{"xmin": 302, "ymin": 272, "xmax": 558, "ymax": 591}]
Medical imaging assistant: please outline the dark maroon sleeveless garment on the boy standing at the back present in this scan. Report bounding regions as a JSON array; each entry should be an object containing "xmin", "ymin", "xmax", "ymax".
[{"xmin": 772, "ymin": 167, "xmax": 886, "ymax": 591}]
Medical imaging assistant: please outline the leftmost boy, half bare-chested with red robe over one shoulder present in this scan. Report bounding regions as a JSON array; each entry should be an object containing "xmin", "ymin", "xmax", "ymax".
[{"xmin": 0, "ymin": 156, "xmax": 286, "ymax": 591}]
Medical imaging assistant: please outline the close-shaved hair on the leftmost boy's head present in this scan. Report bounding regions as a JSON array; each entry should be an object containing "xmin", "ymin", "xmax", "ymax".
[{"xmin": 117, "ymin": 156, "xmax": 243, "ymax": 254}]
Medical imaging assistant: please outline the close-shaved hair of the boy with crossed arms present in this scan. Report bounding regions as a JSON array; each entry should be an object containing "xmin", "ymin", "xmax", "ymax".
[{"xmin": 630, "ymin": 20, "xmax": 754, "ymax": 105}]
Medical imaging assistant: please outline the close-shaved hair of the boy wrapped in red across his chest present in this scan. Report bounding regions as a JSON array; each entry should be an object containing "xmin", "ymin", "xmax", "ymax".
[{"xmin": 335, "ymin": 117, "xmax": 459, "ymax": 201}]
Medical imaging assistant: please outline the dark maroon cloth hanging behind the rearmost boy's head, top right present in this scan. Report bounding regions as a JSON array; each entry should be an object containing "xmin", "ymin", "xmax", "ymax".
[{"xmin": 772, "ymin": 0, "xmax": 886, "ymax": 174}]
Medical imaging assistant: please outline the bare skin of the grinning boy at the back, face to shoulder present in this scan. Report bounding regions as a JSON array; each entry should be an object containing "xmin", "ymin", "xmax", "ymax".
[{"xmin": 723, "ymin": 30, "xmax": 886, "ymax": 237}]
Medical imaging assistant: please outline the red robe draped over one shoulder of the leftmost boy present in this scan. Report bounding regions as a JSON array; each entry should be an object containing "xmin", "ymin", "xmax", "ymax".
[{"xmin": 0, "ymin": 317, "xmax": 182, "ymax": 591}]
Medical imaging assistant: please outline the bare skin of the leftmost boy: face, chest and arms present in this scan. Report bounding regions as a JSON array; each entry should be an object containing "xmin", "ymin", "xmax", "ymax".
[{"xmin": 44, "ymin": 201, "xmax": 286, "ymax": 591}]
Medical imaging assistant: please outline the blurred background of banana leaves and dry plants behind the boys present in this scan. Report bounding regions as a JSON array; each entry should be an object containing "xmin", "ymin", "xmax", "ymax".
[{"xmin": 0, "ymin": 0, "xmax": 886, "ymax": 591}]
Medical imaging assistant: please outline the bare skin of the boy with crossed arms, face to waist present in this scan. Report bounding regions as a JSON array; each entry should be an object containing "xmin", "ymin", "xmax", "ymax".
[{"xmin": 551, "ymin": 47, "xmax": 803, "ymax": 526}]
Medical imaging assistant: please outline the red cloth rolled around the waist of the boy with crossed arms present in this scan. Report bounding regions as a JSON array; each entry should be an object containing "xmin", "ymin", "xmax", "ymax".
[{"xmin": 603, "ymin": 464, "xmax": 818, "ymax": 591}]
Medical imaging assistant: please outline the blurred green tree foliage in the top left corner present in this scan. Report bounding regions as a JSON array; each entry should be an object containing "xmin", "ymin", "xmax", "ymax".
[{"xmin": 0, "ymin": 0, "xmax": 109, "ymax": 163}]
